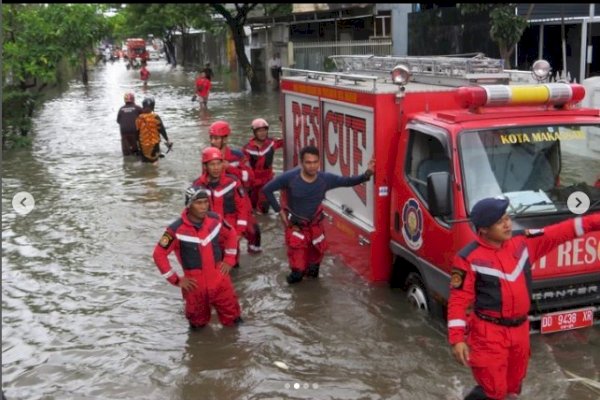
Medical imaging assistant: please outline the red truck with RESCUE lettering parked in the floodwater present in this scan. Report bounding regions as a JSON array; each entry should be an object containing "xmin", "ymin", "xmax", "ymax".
[{"xmin": 280, "ymin": 55, "xmax": 600, "ymax": 333}]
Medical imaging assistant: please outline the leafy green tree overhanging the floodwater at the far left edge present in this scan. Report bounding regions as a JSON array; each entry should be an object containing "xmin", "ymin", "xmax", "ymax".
[{"xmin": 2, "ymin": 4, "xmax": 108, "ymax": 145}]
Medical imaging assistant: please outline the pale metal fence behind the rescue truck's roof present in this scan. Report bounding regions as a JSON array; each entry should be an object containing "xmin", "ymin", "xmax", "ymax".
[{"xmin": 290, "ymin": 39, "xmax": 392, "ymax": 71}]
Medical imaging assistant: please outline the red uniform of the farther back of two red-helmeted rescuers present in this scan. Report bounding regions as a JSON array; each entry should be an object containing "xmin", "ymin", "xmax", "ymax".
[{"xmin": 221, "ymin": 146, "xmax": 262, "ymax": 253}]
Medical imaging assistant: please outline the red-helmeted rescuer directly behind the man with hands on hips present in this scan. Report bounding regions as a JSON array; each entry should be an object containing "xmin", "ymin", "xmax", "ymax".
[{"xmin": 192, "ymin": 147, "xmax": 251, "ymax": 267}]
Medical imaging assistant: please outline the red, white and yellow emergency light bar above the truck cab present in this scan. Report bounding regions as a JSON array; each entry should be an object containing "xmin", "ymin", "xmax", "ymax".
[{"xmin": 456, "ymin": 83, "xmax": 585, "ymax": 108}]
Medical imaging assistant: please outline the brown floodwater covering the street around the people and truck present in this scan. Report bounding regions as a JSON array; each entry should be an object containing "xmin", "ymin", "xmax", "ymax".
[{"xmin": 2, "ymin": 60, "xmax": 600, "ymax": 400}]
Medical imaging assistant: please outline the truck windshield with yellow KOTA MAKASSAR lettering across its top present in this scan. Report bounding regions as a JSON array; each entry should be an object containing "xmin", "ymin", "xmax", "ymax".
[{"xmin": 459, "ymin": 125, "xmax": 600, "ymax": 215}]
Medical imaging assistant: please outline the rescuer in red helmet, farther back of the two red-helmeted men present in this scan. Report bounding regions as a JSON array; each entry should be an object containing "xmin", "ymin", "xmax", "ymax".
[{"xmin": 208, "ymin": 121, "xmax": 262, "ymax": 254}]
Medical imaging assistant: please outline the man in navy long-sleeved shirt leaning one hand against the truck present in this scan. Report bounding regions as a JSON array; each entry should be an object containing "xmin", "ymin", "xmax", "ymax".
[{"xmin": 262, "ymin": 146, "xmax": 375, "ymax": 284}]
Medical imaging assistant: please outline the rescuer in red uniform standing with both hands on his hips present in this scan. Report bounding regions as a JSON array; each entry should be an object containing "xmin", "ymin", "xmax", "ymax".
[{"xmin": 154, "ymin": 187, "xmax": 242, "ymax": 329}]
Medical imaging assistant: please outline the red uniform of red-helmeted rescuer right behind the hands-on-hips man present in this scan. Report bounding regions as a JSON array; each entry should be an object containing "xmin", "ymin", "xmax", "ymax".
[{"xmin": 192, "ymin": 173, "xmax": 251, "ymax": 264}]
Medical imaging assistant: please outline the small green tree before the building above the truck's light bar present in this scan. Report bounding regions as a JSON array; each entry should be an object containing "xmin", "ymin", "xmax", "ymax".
[{"xmin": 457, "ymin": 3, "xmax": 534, "ymax": 69}]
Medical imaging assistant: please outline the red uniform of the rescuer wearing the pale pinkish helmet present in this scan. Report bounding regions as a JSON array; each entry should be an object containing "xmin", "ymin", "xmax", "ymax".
[{"xmin": 242, "ymin": 138, "xmax": 283, "ymax": 213}]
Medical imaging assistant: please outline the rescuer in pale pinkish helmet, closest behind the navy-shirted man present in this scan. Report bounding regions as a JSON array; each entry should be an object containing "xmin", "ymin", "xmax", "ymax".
[{"xmin": 242, "ymin": 118, "xmax": 283, "ymax": 214}]
